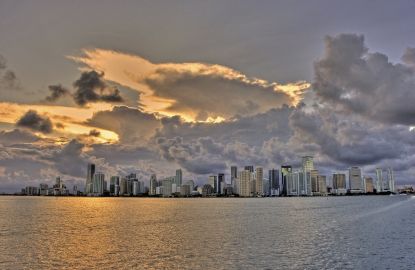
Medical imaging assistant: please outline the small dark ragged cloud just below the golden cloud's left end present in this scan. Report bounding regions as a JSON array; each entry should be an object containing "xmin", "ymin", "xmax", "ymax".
[{"xmin": 73, "ymin": 70, "xmax": 123, "ymax": 106}]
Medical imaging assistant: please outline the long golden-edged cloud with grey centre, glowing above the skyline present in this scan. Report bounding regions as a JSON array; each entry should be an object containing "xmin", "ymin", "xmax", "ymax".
[{"xmin": 71, "ymin": 49, "xmax": 309, "ymax": 122}]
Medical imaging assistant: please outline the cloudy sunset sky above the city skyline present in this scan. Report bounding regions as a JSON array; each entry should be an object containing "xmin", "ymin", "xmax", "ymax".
[{"xmin": 0, "ymin": 0, "xmax": 415, "ymax": 192}]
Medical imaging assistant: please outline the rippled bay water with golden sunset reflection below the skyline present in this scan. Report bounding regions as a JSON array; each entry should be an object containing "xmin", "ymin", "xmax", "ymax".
[{"xmin": 0, "ymin": 196, "xmax": 415, "ymax": 269}]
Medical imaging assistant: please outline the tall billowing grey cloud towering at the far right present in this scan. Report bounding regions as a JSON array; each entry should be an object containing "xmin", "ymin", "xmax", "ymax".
[{"xmin": 313, "ymin": 34, "xmax": 415, "ymax": 125}]
